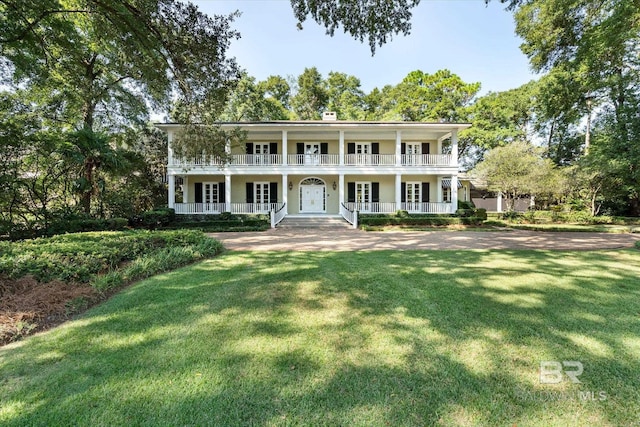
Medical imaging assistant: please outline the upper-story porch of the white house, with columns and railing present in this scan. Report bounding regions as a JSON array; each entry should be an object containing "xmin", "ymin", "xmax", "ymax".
[{"xmin": 160, "ymin": 121, "xmax": 468, "ymax": 168}]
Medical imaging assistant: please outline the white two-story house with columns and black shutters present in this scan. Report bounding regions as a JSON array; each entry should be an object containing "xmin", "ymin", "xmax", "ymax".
[{"xmin": 157, "ymin": 113, "xmax": 470, "ymax": 227}]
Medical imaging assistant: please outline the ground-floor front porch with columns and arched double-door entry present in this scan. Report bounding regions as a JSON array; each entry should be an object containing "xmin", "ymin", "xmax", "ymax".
[{"xmin": 169, "ymin": 174, "xmax": 462, "ymax": 215}]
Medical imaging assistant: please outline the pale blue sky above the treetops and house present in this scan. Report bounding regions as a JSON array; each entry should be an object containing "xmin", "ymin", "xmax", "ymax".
[{"xmin": 193, "ymin": 0, "xmax": 537, "ymax": 94}]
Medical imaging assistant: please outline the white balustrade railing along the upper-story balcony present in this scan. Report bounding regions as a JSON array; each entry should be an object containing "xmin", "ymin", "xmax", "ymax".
[{"xmin": 170, "ymin": 154, "xmax": 451, "ymax": 167}]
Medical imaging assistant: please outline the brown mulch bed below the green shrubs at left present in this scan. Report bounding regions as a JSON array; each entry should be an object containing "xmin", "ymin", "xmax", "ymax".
[{"xmin": 0, "ymin": 276, "xmax": 103, "ymax": 345}]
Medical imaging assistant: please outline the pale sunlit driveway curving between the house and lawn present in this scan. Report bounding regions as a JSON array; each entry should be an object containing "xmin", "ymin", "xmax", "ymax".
[{"xmin": 210, "ymin": 228, "xmax": 640, "ymax": 251}]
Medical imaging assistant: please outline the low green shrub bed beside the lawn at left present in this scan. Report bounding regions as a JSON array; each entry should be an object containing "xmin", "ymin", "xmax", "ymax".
[{"xmin": 0, "ymin": 230, "xmax": 222, "ymax": 283}]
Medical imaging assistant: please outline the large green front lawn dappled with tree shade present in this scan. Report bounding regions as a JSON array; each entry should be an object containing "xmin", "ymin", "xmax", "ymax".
[{"xmin": 0, "ymin": 250, "xmax": 640, "ymax": 426}]
